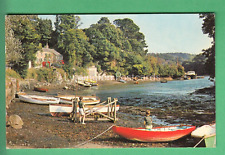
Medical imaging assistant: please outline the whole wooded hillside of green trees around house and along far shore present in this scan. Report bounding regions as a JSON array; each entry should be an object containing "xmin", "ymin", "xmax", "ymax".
[{"xmin": 6, "ymin": 14, "xmax": 214, "ymax": 78}]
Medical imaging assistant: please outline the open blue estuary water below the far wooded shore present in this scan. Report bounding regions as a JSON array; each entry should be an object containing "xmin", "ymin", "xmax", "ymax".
[{"xmin": 80, "ymin": 77, "xmax": 215, "ymax": 108}]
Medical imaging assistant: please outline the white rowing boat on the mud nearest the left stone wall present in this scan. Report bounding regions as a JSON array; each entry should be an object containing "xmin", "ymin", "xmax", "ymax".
[{"xmin": 18, "ymin": 94, "xmax": 60, "ymax": 104}]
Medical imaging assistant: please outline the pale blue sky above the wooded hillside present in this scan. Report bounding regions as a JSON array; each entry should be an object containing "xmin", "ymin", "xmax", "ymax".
[{"xmin": 39, "ymin": 14, "xmax": 212, "ymax": 54}]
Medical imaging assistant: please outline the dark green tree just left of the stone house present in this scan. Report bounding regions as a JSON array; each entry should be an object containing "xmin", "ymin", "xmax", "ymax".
[{"xmin": 10, "ymin": 15, "xmax": 40, "ymax": 78}]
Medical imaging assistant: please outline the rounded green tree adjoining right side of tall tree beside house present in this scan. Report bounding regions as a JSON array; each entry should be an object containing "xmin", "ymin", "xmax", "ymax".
[{"xmin": 85, "ymin": 20, "xmax": 121, "ymax": 73}]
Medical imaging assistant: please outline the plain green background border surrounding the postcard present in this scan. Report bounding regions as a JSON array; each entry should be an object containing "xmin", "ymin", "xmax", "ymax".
[{"xmin": 0, "ymin": 0, "xmax": 225, "ymax": 155}]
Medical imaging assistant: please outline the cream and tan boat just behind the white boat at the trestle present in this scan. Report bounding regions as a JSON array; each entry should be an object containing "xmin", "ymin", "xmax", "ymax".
[{"xmin": 55, "ymin": 95, "xmax": 100, "ymax": 105}]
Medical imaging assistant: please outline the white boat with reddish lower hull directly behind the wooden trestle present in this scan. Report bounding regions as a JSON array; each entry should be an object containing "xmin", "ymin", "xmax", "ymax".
[{"xmin": 49, "ymin": 104, "xmax": 120, "ymax": 116}]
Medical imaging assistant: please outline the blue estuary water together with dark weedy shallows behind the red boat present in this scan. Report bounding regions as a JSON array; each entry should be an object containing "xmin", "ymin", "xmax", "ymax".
[{"xmin": 77, "ymin": 77, "xmax": 215, "ymax": 125}]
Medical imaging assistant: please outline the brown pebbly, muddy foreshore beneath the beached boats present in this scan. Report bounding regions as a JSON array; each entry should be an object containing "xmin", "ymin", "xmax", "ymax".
[{"xmin": 6, "ymin": 81, "xmax": 215, "ymax": 148}]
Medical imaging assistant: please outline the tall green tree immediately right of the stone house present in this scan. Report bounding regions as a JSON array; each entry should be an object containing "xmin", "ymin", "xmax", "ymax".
[{"xmin": 54, "ymin": 15, "xmax": 96, "ymax": 76}]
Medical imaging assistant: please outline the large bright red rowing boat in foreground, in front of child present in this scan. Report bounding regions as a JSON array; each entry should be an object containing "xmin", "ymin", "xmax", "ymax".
[{"xmin": 112, "ymin": 125, "xmax": 196, "ymax": 142}]
